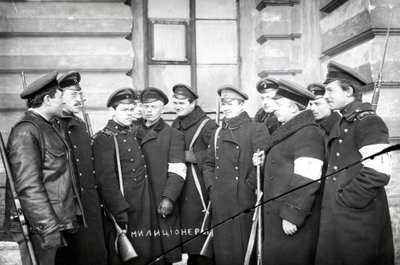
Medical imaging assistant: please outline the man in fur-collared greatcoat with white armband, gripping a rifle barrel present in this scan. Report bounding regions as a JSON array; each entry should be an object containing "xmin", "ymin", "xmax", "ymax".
[{"xmin": 253, "ymin": 80, "xmax": 324, "ymax": 265}]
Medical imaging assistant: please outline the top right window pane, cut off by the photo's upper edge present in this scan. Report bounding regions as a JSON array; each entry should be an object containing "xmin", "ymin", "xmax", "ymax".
[{"xmin": 196, "ymin": 0, "xmax": 236, "ymax": 19}]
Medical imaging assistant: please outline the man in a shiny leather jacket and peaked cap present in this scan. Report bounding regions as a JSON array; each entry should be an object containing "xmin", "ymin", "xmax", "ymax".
[{"xmin": 6, "ymin": 72, "xmax": 83, "ymax": 265}]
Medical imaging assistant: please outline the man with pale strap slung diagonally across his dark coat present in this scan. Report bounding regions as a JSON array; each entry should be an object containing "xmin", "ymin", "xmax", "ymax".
[{"xmin": 172, "ymin": 84, "xmax": 217, "ymax": 265}]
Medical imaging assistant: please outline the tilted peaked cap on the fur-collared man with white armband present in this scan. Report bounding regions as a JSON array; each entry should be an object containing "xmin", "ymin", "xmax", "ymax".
[{"xmin": 275, "ymin": 79, "xmax": 315, "ymax": 106}]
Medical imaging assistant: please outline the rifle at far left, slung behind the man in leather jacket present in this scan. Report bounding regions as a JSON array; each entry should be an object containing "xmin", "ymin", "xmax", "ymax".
[{"xmin": 0, "ymin": 132, "xmax": 38, "ymax": 265}]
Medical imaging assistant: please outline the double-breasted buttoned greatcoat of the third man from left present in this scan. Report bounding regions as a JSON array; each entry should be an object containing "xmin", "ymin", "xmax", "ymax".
[{"xmin": 93, "ymin": 120, "xmax": 161, "ymax": 264}]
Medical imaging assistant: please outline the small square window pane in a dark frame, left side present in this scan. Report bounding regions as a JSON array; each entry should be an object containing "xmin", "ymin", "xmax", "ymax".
[{"xmin": 152, "ymin": 23, "xmax": 188, "ymax": 62}]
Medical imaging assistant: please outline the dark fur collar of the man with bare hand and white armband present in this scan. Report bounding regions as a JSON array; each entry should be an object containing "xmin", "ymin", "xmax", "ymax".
[{"xmin": 266, "ymin": 110, "xmax": 317, "ymax": 151}]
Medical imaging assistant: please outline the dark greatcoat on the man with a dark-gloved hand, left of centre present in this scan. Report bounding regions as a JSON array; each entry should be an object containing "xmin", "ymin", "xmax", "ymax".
[{"xmin": 137, "ymin": 119, "xmax": 185, "ymax": 263}]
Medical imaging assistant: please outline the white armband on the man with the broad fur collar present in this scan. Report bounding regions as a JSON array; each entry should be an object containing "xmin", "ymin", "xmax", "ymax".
[{"xmin": 293, "ymin": 157, "xmax": 324, "ymax": 180}]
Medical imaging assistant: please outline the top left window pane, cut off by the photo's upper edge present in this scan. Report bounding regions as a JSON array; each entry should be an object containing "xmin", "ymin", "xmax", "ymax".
[{"xmin": 148, "ymin": 0, "xmax": 190, "ymax": 19}]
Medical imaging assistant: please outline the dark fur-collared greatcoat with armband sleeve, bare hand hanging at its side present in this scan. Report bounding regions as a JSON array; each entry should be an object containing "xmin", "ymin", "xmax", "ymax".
[{"xmin": 263, "ymin": 110, "xmax": 324, "ymax": 265}]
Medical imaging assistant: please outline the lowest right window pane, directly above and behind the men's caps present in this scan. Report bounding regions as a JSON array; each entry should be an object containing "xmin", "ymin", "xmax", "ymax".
[{"xmin": 197, "ymin": 65, "xmax": 238, "ymax": 111}]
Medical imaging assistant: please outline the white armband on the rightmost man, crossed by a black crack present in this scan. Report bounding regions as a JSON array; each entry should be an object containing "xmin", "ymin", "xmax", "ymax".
[{"xmin": 359, "ymin": 144, "xmax": 392, "ymax": 175}]
